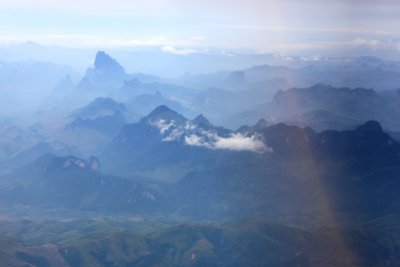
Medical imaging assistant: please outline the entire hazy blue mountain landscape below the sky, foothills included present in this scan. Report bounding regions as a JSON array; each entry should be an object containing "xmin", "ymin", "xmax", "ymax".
[{"xmin": 0, "ymin": 49, "xmax": 400, "ymax": 267}]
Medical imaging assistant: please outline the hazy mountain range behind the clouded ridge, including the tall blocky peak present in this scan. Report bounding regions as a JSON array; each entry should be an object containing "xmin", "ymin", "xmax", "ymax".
[{"xmin": 36, "ymin": 51, "xmax": 400, "ymax": 131}]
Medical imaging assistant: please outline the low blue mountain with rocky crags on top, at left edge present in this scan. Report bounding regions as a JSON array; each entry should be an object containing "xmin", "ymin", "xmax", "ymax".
[{"xmin": 1, "ymin": 154, "xmax": 168, "ymax": 214}]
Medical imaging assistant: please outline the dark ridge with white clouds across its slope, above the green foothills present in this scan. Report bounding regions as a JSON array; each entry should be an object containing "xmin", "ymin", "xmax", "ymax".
[{"xmin": 1, "ymin": 106, "xmax": 400, "ymax": 226}]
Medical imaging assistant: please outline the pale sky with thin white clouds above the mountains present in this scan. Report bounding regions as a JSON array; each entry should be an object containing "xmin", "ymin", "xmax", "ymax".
[{"xmin": 0, "ymin": 0, "xmax": 400, "ymax": 57}]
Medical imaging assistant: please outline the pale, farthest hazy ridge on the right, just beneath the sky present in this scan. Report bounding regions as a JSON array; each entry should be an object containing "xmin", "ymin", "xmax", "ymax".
[{"xmin": 177, "ymin": 57, "xmax": 400, "ymax": 93}]
